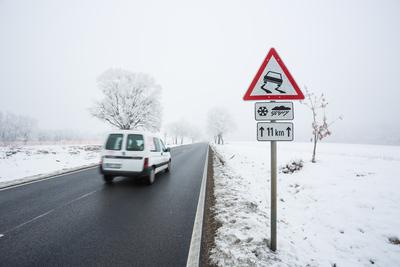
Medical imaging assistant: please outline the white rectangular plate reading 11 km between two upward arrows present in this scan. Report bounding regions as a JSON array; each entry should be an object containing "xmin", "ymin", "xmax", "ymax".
[{"xmin": 257, "ymin": 122, "xmax": 293, "ymax": 141}]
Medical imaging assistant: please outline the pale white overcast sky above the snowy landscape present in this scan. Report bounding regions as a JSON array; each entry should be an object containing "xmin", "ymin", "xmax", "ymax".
[{"xmin": 0, "ymin": 0, "xmax": 400, "ymax": 144}]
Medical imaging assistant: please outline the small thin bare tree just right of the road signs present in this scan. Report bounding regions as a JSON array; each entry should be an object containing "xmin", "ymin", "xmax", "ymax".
[{"xmin": 300, "ymin": 87, "xmax": 343, "ymax": 163}]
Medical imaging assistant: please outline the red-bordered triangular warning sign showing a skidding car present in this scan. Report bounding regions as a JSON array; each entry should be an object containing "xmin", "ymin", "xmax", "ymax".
[{"xmin": 243, "ymin": 48, "xmax": 304, "ymax": 100}]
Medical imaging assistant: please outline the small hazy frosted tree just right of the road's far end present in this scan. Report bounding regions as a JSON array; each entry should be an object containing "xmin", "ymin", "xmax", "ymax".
[{"xmin": 207, "ymin": 107, "xmax": 235, "ymax": 144}]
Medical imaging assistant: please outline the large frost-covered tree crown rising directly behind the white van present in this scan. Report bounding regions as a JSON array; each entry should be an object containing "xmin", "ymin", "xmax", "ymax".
[{"xmin": 91, "ymin": 69, "xmax": 162, "ymax": 131}]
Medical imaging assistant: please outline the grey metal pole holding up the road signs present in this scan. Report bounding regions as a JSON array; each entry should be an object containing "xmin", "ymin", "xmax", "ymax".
[{"xmin": 271, "ymin": 131, "xmax": 277, "ymax": 251}]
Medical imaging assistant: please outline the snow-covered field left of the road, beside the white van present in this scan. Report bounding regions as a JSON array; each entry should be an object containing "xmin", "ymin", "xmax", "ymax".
[{"xmin": 0, "ymin": 145, "xmax": 101, "ymax": 187}]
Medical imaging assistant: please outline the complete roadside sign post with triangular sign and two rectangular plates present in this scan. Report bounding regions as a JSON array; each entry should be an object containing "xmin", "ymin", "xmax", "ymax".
[{"xmin": 243, "ymin": 48, "xmax": 304, "ymax": 251}]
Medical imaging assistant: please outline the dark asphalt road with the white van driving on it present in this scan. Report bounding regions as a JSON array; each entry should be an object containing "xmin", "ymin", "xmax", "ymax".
[{"xmin": 0, "ymin": 144, "xmax": 208, "ymax": 266}]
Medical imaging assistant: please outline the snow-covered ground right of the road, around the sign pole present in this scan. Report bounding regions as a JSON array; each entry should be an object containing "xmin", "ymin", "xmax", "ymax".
[{"xmin": 211, "ymin": 142, "xmax": 400, "ymax": 267}]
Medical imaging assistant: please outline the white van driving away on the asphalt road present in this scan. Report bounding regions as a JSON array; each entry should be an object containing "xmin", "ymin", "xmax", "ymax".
[{"xmin": 100, "ymin": 130, "xmax": 171, "ymax": 184}]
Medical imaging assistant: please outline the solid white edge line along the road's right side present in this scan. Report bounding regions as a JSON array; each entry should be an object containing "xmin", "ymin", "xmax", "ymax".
[{"xmin": 186, "ymin": 146, "xmax": 210, "ymax": 267}]
